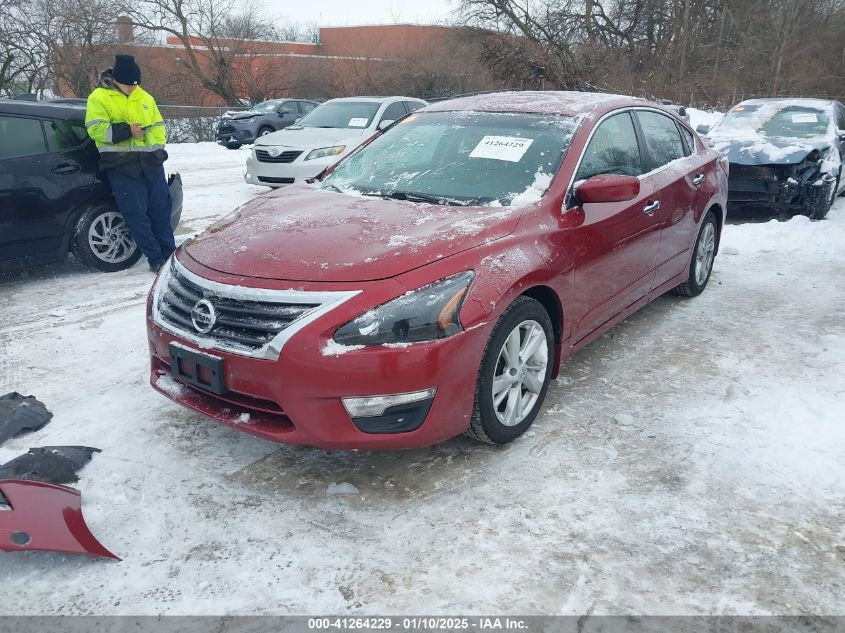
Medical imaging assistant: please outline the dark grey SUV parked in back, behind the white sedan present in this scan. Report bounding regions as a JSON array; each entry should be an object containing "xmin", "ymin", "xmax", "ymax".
[{"xmin": 217, "ymin": 99, "xmax": 320, "ymax": 149}]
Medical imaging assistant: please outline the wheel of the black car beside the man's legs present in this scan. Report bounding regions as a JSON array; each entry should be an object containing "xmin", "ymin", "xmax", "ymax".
[{"xmin": 70, "ymin": 204, "xmax": 141, "ymax": 273}]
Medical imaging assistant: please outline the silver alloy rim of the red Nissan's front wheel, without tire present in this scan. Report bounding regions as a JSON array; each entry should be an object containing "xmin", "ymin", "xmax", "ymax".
[{"xmin": 493, "ymin": 320, "xmax": 549, "ymax": 426}]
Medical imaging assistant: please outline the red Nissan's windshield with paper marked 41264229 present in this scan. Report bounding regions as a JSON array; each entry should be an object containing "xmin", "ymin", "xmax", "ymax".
[{"xmin": 322, "ymin": 112, "xmax": 578, "ymax": 206}]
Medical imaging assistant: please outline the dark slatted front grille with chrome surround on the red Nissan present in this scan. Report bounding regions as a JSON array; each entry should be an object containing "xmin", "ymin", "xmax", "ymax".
[{"xmin": 158, "ymin": 267, "xmax": 320, "ymax": 353}]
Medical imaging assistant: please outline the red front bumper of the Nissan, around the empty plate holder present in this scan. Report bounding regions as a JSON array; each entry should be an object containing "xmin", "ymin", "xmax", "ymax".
[{"xmin": 147, "ymin": 254, "xmax": 490, "ymax": 449}]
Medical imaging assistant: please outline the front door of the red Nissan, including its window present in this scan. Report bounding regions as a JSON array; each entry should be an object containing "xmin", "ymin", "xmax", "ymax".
[{"xmin": 573, "ymin": 111, "xmax": 661, "ymax": 343}]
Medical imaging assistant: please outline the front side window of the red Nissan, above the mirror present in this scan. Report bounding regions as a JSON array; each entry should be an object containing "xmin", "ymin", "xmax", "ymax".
[{"xmin": 575, "ymin": 112, "xmax": 643, "ymax": 180}]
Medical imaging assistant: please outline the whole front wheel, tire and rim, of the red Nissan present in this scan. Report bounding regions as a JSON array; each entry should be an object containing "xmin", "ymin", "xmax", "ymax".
[{"xmin": 466, "ymin": 296, "xmax": 554, "ymax": 444}]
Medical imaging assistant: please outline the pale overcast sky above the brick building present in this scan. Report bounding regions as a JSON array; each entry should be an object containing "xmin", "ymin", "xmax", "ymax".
[{"xmin": 263, "ymin": 0, "xmax": 455, "ymax": 26}]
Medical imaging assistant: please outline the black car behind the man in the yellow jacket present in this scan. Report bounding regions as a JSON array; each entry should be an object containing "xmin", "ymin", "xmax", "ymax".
[{"xmin": 0, "ymin": 99, "xmax": 182, "ymax": 273}]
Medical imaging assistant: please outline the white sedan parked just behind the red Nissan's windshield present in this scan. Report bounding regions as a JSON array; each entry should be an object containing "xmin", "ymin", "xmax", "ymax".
[{"xmin": 244, "ymin": 97, "xmax": 427, "ymax": 187}]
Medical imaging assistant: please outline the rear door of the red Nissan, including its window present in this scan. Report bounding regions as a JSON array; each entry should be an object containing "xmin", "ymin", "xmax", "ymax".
[{"xmin": 635, "ymin": 110, "xmax": 717, "ymax": 288}]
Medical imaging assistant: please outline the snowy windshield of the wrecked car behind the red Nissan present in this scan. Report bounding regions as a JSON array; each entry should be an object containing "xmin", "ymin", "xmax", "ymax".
[{"xmin": 713, "ymin": 102, "xmax": 830, "ymax": 138}]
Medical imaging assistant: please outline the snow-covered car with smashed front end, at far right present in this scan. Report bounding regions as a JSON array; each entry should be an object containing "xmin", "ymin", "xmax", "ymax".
[{"xmin": 698, "ymin": 99, "xmax": 845, "ymax": 220}]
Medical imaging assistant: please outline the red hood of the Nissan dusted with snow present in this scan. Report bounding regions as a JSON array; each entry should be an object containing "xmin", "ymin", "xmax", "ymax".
[{"xmin": 184, "ymin": 185, "xmax": 520, "ymax": 282}]
